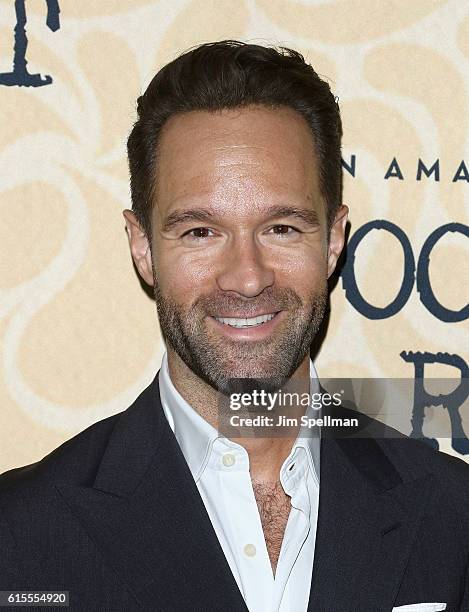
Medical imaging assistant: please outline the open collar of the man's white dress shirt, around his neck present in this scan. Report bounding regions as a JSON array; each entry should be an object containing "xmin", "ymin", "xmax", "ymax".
[{"xmin": 159, "ymin": 351, "xmax": 320, "ymax": 484}]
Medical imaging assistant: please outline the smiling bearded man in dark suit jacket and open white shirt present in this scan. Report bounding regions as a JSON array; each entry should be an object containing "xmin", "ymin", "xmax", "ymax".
[{"xmin": 0, "ymin": 41, "xmax": 469, "ymax": 612}]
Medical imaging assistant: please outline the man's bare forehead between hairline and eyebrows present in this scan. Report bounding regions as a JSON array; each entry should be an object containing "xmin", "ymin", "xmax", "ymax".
[{"xmin": 155, "ymin": 107, "xmax": 319, "ymax": 214}]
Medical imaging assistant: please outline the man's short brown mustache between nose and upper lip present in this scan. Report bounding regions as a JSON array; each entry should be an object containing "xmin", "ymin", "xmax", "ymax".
[{"xmin": 192, "ymin": 287, "xmax": 302, "ymax": 317}]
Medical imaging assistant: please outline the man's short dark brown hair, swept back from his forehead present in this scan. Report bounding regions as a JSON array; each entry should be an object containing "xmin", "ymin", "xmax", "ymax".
[{"xmin": 127, "ymin": 40, "xmax": 342, "ymax": 240}]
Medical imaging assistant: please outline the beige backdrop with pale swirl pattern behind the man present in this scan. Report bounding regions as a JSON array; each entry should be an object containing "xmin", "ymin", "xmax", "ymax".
[{"xmin": 0, "ymin": 0, "xmax": 469, "ymax": 472}]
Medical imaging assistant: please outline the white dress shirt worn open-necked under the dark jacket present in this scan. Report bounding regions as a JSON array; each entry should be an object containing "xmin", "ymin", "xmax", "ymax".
[{"xmin": 159, "ymin": 353, "xmax": 320, "ymax": 612}]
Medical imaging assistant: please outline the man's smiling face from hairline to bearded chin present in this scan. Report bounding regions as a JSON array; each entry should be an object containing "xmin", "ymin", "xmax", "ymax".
[{"xmin": 122, "ymin": 107, "xmax": 346, "ymax": 392}]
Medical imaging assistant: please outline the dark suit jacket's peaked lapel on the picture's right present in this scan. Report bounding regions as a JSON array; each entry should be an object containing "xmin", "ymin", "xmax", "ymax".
[{"xmin": 308, "ymin": 437, "xmax": 433, "ymax": 612}]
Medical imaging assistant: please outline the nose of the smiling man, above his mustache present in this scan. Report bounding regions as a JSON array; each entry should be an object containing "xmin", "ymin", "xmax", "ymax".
[{"xmin": 217, "ymin": 236, "xmax": 274, "ymax": 298}]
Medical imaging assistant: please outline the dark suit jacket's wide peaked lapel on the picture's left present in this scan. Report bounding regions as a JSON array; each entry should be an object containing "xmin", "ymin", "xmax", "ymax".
[{"xmin": 57, "ymin": 376, "xmax": 246, "ymax": 612}]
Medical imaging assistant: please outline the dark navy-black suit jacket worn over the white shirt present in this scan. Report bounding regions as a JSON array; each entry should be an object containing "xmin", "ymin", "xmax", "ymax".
[{"xmin": 0, "ymin": 375, "xmax": 469, "ymax": 612}]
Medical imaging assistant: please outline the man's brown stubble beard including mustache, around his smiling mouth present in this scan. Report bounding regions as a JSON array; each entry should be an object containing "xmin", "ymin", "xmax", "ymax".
[{"xmin": 153, "ymin": 272, "xmax": 328, "ymax": 395}]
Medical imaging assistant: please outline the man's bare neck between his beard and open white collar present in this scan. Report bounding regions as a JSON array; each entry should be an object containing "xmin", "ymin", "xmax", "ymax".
[{"xmin": 168, "ymin": 347, "xmax": 310, "ymax": 482}]
